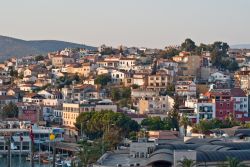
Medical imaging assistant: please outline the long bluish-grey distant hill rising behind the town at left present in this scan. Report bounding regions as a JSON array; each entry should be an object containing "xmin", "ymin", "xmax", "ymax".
[{"xmin": 0, "ymin": 36, "xmax": 96, "ymax": 60}]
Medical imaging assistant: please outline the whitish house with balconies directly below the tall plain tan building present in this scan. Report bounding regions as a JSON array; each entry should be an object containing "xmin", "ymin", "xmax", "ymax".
[{"xmin": 175, "ymin": 81, "xmax": 196, "ymax": 96}]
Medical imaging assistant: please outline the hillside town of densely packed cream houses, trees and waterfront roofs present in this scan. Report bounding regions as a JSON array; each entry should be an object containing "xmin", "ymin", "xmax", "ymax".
[{"xmin": 0, "ymin": 39, "xmax": 250, "ymax": 167}]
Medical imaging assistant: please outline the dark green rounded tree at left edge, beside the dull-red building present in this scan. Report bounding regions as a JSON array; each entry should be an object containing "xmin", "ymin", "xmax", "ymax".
[{"xmin": 2, "ymin": 102, "xmax": 18, "ymax": 118}]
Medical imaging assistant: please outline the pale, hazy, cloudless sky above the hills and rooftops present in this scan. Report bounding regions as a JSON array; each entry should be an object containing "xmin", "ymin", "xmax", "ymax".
[{"xmin": 0, "ymin": 0, "xmax": 250, "ymax": 48}]
